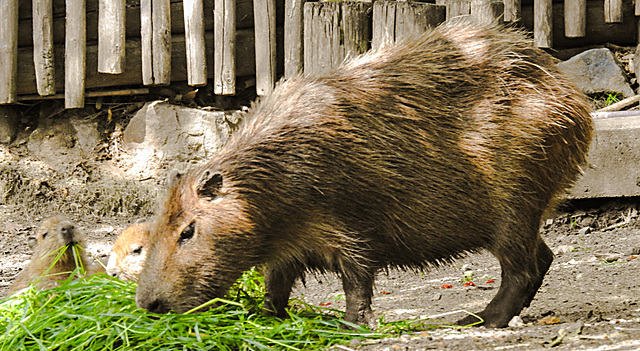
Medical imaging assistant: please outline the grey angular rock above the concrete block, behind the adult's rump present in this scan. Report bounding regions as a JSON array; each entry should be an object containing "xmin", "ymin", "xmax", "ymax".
[{"xmin": 558, "ymin": 48, "xmax": 635, "ymax": 97}]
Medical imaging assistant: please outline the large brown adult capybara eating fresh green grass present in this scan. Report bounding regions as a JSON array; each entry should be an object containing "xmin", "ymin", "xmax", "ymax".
[{"xmin": 136, "ymin": 23, "xmax": 593, "ymax": 327}]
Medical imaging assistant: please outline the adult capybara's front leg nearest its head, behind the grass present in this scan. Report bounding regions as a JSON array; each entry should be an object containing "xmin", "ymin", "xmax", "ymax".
[{"xmin": 264, "ymin": 264, "xmax": 303, "ymax": 318}]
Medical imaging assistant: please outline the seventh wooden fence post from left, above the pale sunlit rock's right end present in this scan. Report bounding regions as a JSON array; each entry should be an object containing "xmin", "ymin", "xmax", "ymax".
[{"xmin": 213, "ymin": 0, "xmax": 236, "ymax": 95}]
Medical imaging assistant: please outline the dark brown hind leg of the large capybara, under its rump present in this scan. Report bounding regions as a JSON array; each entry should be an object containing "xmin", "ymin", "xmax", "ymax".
[{"xmin": 458, "ymin": 231, "xmax": 553, "ymax": 328}]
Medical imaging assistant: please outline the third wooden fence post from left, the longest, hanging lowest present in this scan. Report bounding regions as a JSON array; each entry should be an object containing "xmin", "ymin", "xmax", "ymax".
[{"xmin": 64, "ymin": 0, "xmax": 87, "ymax": 108}]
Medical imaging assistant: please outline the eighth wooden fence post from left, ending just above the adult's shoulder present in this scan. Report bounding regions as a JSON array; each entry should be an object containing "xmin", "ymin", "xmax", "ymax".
[{"xmin": 253, "ymin": 0, "xmax": 276, "ymax": 96}]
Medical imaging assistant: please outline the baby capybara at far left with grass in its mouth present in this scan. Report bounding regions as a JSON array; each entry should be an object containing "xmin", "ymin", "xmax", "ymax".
[{"xmin": 9, "ymin": 214, "xmax": 104, "ymax": 293}]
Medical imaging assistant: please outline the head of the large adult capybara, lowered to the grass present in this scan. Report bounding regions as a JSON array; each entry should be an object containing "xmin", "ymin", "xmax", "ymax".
[{"xmin": 136, "ymin": 169, "xmax": 260, "ymax": 313}]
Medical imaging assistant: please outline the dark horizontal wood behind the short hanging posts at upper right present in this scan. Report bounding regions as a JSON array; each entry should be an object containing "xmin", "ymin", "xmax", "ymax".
[{"xmin": 522, "ymin": 0, "xmax": 638, "ymax": 48}]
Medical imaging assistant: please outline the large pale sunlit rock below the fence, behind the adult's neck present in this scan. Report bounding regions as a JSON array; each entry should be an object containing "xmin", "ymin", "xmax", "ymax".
[{"xmin": 123, "ymin": 101, "xmax": 239, "ymax": 178}]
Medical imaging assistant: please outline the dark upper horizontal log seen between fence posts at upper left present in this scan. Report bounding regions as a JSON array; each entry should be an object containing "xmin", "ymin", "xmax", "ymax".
[{"xmin": 18, "ymin": 0, "xmax": 284, "ymax": 47}]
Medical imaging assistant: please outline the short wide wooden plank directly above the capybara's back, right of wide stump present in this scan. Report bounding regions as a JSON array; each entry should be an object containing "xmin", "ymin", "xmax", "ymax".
[{"xmin": 396, "ymin": 2, "xmax": 447, "ymax": 42}]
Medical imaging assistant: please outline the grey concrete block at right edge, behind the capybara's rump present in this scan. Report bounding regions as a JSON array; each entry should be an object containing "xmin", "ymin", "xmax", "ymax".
[{"xmin": 568, "ymin": 111, "xmax": 640, "ymax": 199}]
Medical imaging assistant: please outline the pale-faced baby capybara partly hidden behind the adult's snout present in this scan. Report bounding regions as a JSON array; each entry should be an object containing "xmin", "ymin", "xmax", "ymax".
[{"xmin": 107, "ymin": 222, "xmax": 149, "ymax": 282}]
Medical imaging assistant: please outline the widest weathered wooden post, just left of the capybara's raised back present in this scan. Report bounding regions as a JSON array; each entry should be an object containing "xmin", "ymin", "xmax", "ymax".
[{"xmin": 304, "ymin": 2, "xmax": 371, "ymax": 75}]
